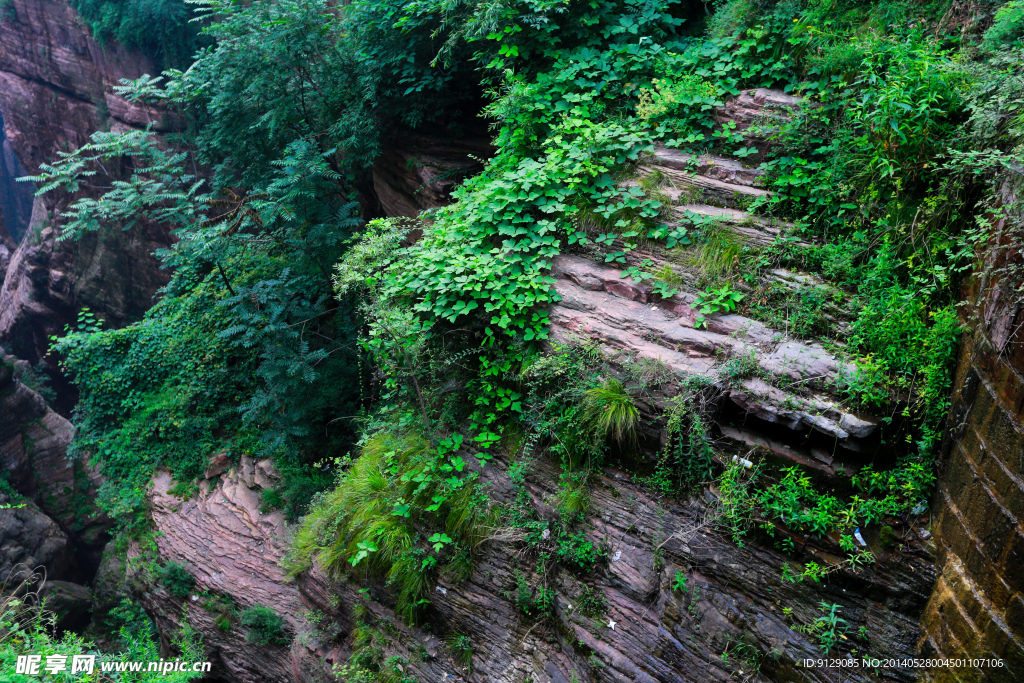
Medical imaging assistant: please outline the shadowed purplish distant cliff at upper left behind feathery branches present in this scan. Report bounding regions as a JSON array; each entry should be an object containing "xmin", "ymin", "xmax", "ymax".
[{"xmin": 0, "ymin": 0, "xmax": 170, "ymax": 364}]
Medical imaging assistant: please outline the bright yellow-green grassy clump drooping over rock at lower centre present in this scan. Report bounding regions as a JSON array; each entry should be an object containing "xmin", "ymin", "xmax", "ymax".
[{"xmin": 286, "ymin": 431, "xmax": 495, "ymax": 622}]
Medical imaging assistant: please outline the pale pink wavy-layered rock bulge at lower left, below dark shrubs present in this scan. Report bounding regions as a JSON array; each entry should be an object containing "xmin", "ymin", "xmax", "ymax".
[{"xmin": 130, "ymin": 457, "xmax": 341, "ymax": 683}]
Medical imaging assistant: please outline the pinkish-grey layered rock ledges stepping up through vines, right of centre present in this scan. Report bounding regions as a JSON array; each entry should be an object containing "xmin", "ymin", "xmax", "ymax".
[{"xmin": 550, "ymin": 94, "xmax": 881, "ymax": 476}]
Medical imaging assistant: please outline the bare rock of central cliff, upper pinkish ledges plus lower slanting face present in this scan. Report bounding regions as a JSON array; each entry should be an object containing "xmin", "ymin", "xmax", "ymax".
[{"xmin": 128, "ymin": 91, "xmax": 935, "ymax": 683}]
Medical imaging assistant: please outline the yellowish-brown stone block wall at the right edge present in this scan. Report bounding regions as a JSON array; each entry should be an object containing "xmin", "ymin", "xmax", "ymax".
[{"xmin": 921, "ymin": 179, "xmax": 1024, "ymax": 683}]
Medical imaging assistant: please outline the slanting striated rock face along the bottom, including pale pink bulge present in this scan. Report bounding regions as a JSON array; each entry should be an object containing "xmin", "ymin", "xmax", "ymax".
[{"xmin": 139, "ymin": 450, "xmax": 934, "ymax": 683}]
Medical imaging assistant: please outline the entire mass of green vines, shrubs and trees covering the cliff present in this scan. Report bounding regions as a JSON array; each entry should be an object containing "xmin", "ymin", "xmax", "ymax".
[{"xmin": 35, "ymin": 0, "xmax": 1024, "ymax": 647}]
